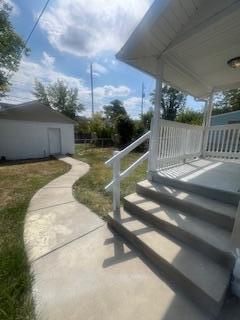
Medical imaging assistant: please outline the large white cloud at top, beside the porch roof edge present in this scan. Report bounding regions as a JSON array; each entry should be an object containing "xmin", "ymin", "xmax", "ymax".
[{"xmin": 40, "ymin": 0, "xmax": 151, "ymax": 57}]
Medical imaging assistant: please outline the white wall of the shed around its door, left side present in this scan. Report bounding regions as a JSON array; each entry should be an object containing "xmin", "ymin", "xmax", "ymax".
[{"xmin": 0, "ymin": 119, "xmax": 74, "ymax": 160}]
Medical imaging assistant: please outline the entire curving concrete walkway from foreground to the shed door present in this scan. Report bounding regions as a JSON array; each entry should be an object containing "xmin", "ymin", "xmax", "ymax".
[{"xmin": 24, "ymin": 157, "xmax": 239, "ymax": 320}]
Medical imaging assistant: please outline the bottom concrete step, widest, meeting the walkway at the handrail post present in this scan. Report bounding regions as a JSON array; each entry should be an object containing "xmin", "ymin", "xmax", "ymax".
[{"xmin": 109, "ymin": 210, "xmax": 230, "ymax": 317}]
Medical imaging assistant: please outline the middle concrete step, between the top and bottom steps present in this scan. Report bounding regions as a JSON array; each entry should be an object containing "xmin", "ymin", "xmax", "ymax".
[{"xmin": 124, "ymin": 193, "xmax": 234, "ymax": 269}]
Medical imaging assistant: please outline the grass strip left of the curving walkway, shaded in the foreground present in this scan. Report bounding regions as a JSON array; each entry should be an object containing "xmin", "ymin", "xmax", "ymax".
[{"xmin": 0, "ymin": 160, "xmax": 69, "ymax": 320}]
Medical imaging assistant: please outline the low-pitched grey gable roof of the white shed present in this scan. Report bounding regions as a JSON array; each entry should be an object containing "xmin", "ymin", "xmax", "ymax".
[{"xmin": 0, "ymin": 100, "xmax": 75, "ymax": 124}]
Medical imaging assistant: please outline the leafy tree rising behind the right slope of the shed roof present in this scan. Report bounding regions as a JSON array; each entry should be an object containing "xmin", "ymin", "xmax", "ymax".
[{"xmin": 33, "ymin": 80, "xmax": 84, "ymax": 119}]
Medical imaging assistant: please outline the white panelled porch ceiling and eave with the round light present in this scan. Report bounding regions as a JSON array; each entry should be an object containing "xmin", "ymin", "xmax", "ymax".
[{"xmin": 117, "ymin": 0, "xmax": 240, "ymax": 98}]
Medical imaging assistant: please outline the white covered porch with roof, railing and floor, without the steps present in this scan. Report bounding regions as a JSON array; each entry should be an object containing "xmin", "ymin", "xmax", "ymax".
[{"xmin": 110, "ymin": 0, "xmax": 240, "ymax": 242}]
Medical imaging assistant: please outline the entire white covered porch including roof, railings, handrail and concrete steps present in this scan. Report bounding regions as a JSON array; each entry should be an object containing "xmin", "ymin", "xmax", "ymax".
[{"xmin": 106, "ymin": 0, "xmax": 240, "ymax": 319}]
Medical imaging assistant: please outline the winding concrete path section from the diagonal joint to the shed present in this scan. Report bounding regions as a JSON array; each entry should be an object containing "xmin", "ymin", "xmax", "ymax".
[{"xmin": 24, "ymin": 157, "xmax": 104, "ymax": 261}]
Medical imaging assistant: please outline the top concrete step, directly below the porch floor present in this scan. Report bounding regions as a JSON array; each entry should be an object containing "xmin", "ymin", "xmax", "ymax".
[{"xmin": 137, "ymin": 180, "xmax": 237, "ymax": 231}]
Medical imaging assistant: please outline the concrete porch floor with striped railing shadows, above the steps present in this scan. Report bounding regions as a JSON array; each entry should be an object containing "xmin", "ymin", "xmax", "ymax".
[{"xmin": 159, "ymin": 159, "xmax": 240, "ymax": 193}]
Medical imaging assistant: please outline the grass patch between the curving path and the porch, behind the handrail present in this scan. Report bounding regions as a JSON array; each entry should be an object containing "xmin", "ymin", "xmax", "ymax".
[{"xmin": 74, "ymin": 145, "xmax": 147, "ymax": 219}]
